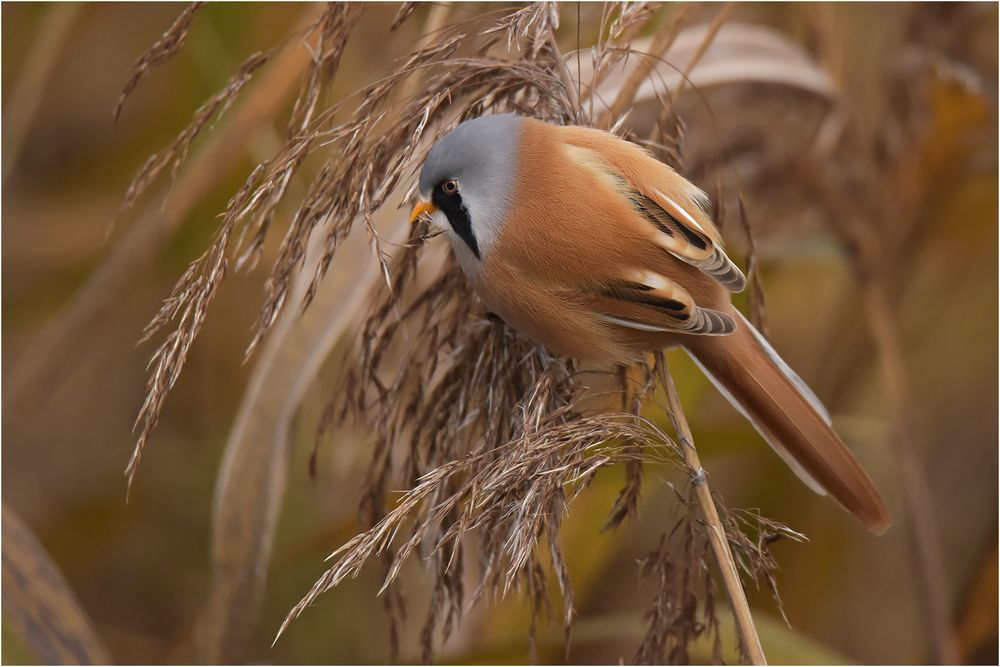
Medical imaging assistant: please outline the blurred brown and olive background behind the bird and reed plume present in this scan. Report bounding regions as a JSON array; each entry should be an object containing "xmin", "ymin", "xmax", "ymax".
[{"xmin": 2, "ymin": 3, "xmax": 998, "ymax": 663}]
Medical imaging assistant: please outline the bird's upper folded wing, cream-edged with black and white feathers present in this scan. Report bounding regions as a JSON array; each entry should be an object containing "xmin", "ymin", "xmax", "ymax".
[{"xmin": 567, "ymin": 136, "xmax": 746, "ymax": 292}]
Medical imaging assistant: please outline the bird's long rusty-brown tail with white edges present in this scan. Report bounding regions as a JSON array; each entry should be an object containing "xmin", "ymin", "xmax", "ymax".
[{"xmin": 687, "ymin": 311, "xmax": 892, "ymax": 534}]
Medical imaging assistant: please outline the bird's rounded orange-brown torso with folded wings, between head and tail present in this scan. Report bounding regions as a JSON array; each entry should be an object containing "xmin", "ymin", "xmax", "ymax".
[{"xmin": 475, "ymin": 119, "xmax": 729, "ymax": 362}]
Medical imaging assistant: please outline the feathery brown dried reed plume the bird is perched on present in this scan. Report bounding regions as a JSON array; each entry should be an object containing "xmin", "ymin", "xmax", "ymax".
[{"xmin": 123, "ymin": 3, "xmax": 801, "ymax": 662}]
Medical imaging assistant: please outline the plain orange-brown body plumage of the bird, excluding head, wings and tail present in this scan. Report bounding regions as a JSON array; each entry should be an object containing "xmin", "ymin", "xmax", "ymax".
[{"xmin": 478, "ymin": 120, "xmax": 730, "ymax": 361}]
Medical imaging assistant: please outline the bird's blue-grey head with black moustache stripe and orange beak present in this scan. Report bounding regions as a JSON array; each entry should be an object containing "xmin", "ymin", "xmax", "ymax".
[{"xmin": 414, "ymin": 114, "xmax": 522, "ymax": 272}]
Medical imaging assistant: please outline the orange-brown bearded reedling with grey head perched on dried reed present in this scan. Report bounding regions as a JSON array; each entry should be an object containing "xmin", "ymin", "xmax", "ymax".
[{"xmin": 410, "ymin": 114, "xmax": 891, "ymax": 534}]
